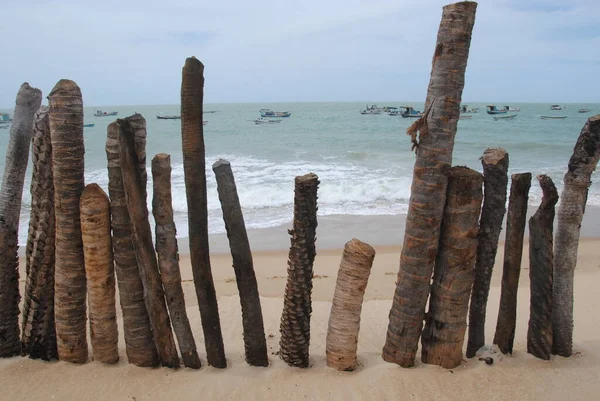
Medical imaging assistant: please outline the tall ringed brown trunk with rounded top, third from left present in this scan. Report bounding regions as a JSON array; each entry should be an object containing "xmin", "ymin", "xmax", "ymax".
[{"xmin": 48, "ymin": 79, "xmax": 88, "ymax": 363}]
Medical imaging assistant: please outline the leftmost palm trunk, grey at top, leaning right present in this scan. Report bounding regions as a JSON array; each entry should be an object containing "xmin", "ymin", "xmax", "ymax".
[{"xmin": 0, "ymin": 82, "xmax": 42, "ymax": 358}]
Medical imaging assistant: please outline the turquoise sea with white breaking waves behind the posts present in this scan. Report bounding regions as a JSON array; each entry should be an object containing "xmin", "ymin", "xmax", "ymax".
[{"xmin": 0, "ymin": 102, "xmax": 600, "ymax": 241}]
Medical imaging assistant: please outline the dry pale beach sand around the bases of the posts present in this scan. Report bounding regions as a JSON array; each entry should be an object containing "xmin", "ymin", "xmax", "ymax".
[{"xmin": 0, "ymin": 239, "xmax": 600, "ymax": 401}]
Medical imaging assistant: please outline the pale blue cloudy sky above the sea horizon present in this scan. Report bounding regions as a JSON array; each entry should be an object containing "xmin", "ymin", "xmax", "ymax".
[{"xmin": 0, "ymin": 0, "xmax": 600, "ymax": 108}]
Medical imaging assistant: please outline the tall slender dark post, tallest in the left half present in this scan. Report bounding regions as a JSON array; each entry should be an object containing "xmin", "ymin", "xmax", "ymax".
[{"xmin": 181, "ymin": 57, "xmax": 227, "ymax": 368}]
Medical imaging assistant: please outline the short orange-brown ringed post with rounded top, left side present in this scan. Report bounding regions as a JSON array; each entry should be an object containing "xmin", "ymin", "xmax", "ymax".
[{"xmin": 79, "ymin": 184, "xmax": 119, "ymax": 364}]
